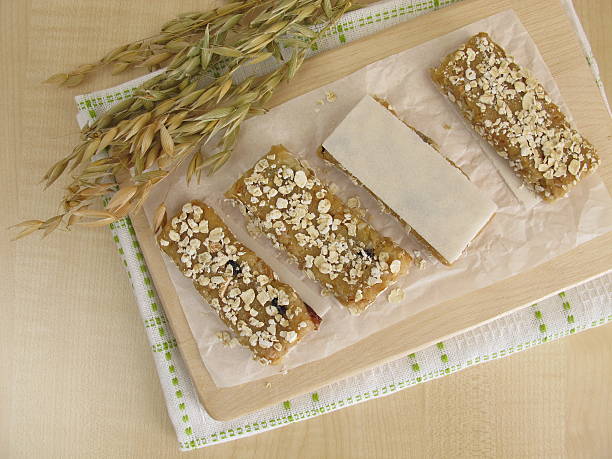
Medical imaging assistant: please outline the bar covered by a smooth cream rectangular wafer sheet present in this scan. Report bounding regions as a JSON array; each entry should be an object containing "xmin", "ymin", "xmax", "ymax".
[{"xmin": 319, "ymin": 96, "xmax": 497, "ymax": 264}]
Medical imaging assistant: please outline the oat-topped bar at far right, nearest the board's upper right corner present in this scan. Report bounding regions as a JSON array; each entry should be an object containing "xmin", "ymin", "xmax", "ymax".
[{"xmin": 431, "ymin": 33, "xmax": 600, "ymax": 201}]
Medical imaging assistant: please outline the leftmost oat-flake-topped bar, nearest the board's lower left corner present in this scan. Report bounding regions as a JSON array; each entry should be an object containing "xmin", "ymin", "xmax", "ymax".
[{"xmin": 158, "ymin": 201, "xmax": 321, "ymax": 364}]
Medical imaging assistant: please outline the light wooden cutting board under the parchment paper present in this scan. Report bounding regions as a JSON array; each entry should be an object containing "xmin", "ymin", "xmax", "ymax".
[{"xmin": 133, "ymin": 0, "xmax": 612, "ymax": 420}]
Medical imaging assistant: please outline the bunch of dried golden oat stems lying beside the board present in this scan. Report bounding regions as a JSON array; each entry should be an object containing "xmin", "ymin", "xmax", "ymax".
[{"xmin": 17, "ymin": 0, "xmax": 351, "ymax": 237}]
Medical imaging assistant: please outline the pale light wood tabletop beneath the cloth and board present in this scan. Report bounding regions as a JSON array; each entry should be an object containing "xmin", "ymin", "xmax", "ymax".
[{"xmin": 0, "ymin": 0, "xmax": 612, "ymax": 458}]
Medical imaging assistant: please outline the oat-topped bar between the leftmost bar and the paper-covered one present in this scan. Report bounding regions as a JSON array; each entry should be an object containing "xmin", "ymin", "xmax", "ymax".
[{"xmin": 226, "ymin": 146, "xmax": 412, "ymax": 314}]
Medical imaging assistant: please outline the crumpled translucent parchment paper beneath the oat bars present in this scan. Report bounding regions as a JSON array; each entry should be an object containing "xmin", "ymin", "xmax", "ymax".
[{"xmin": 145, "ymin": 11, "xmax": 612, "ymax": 387}]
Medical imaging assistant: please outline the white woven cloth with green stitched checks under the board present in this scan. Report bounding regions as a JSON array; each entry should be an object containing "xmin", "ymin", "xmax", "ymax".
[{"xmin": 76, "ymin": 0, "xmax": 612, "ymax": 450}]
